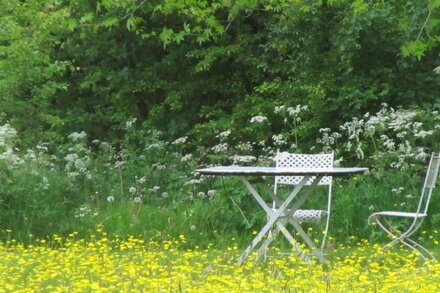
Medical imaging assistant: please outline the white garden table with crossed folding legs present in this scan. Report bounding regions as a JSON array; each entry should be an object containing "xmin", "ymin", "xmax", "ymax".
[{"xmin": 196, "ymin": 166, "xmax": 368, "ymax": 265}]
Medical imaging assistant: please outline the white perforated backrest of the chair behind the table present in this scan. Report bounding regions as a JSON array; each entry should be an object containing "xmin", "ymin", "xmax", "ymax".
[{"xmin": 275, "ymin": 152, "xmax": 333, "ymax": 193}]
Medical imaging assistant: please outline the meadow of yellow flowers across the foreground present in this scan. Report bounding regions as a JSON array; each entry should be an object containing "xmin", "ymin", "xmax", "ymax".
[{"xmin": 0, "ymin": 230, "xmax": 440, "ymax": 292}]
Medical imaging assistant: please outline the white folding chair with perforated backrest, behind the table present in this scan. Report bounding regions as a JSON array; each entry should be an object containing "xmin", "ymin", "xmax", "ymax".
[{"xmin": 266, "ymin": 152, "xmax": 333, "ymax": 261}]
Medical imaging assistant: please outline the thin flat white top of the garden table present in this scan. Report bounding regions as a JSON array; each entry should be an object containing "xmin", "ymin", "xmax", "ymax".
[{"xmin": 196, "ymin": 165, "xmax": 368, "ymax": 176}]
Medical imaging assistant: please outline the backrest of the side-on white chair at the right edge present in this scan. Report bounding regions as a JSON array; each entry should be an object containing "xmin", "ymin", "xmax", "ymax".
[{"xmin": 417, "ymin": 153, "xmax": 440, "ymax": 214}]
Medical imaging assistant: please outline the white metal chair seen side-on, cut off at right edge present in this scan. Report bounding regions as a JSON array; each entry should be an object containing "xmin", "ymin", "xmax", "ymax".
[{"xmin": 368, "ymin": 153, "xmax": 440, "ymax": 260}]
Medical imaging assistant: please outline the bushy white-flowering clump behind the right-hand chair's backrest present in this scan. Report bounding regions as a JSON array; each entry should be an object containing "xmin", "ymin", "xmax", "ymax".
[{"xmin": 316, "ymin": 104, "xmax": 440, "ymax": 171}]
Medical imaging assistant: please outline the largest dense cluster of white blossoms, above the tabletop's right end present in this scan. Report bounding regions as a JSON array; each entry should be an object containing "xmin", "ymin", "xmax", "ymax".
[{"xmin": 316, "ymin": 104, "xmax": 435, "ymax": 169}]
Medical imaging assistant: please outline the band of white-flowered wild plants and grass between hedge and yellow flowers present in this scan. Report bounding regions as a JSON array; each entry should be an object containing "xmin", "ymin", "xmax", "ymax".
[{"xmin": 0, "ymin": 101, "xmax": 440, "ymax": 245}]
